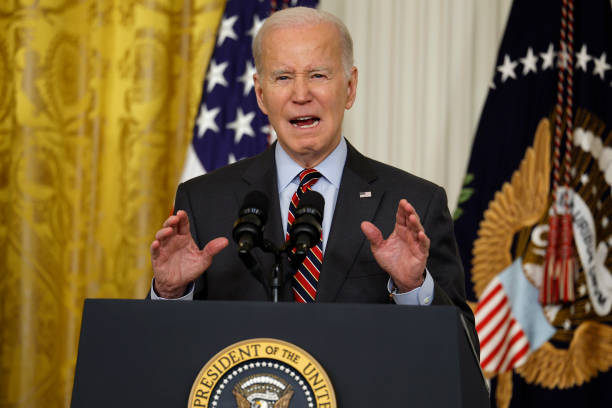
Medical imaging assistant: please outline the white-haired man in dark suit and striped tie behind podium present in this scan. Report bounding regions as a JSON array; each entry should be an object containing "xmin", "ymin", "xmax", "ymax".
[{"xmin": 151, "ymin": 8, "xmax": 474, "ymax": 344}]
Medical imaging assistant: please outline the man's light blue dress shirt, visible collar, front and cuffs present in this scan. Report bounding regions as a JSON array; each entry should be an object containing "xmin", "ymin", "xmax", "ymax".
[{"xmin": 151, "ymin": 138, "xmax": 434, "ymax": 306}]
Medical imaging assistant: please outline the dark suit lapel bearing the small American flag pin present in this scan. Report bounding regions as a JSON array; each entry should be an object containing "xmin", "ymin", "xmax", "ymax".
[{"xmin": 316, "ymin": 142, "xmax": 384, "ymax": 302}]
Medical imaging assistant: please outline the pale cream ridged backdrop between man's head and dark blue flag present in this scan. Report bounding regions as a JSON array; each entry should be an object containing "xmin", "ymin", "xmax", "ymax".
[{"xmin": 320, "ymin": 0, "xmax": 512, "ymax": 210}]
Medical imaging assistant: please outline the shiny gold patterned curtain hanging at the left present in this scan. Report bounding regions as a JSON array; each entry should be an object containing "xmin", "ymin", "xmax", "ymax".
[{"xmin": 0, "ymin": 0, "xmax": 225, "ymax": 407}]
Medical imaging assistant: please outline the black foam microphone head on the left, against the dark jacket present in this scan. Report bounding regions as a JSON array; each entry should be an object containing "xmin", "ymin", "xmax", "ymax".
[{"xmin": 232, "ymin": 191, "xmax": 269, "ymax": 254}]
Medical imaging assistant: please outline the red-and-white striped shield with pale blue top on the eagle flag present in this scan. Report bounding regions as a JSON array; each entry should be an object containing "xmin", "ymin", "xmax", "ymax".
[{"xmin": 475, "ymin": 258, "xmax": 555, "ymax": 373}]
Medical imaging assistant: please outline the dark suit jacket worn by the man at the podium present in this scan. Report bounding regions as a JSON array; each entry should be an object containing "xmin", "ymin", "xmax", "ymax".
[{"xmin": 175, "ymin": 143, "xmax": 478, "ymax": 344}]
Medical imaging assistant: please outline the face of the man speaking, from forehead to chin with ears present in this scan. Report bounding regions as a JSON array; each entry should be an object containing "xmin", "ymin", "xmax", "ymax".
[{"xmin": 254, "ymin": 23, "xmax": 357, "ymax": 167}]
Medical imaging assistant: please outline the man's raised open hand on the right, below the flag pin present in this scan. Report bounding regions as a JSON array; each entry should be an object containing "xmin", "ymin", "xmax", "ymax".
[{"xmin": 361, "ymin": 199, "xmax": 430, "ymax": 293}]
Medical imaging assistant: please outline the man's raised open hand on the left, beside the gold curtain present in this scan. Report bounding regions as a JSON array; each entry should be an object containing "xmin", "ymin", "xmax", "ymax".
[{"xmin": 151, "ymin": 210, "xmax": 229, "ymax": 299}]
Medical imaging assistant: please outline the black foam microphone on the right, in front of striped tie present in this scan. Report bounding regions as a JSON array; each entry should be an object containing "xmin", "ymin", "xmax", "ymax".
[{"xmin": 289, "ymin": 190, "xmax": 325, "ymax": 267}]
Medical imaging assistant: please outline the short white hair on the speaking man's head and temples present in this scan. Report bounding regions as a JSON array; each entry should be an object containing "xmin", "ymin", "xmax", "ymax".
[{"xmin": 253, "ymin": 7, "xmax": 353, "ymax": 78}]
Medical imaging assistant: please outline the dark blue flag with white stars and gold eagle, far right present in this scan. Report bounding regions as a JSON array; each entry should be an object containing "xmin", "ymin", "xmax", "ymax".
[{"xmin": 454, "ymin": 0, "xmax": 612, "ymax": 407}]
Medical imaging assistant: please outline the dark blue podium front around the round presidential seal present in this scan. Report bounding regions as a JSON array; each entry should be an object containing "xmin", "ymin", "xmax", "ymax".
[{"xmin": 71, "ymin": 299, "xmax": 489, "ymax": 408}]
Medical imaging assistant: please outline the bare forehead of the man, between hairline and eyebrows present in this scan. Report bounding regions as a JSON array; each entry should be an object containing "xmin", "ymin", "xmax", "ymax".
[{"xmin": 262, "ymin": 23, "xmax": 342, "ymax": 69}]
